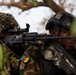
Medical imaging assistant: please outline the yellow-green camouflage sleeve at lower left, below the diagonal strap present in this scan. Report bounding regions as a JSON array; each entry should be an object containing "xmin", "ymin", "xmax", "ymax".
[{"xmin": 0, "ymin": 44, "xmax": 19, "ymax": 75}]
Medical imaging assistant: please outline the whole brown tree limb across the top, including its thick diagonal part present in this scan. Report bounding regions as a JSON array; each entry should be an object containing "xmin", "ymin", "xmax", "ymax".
[{"xmin": 0, "ymin": 0, "xmax": 65, "ymax": 12}]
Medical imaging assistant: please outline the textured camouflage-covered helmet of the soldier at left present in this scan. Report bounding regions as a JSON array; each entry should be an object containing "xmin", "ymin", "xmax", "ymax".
[{"xmin": 0, "ymin": 12, "xmax": 19, "ymax": 33}]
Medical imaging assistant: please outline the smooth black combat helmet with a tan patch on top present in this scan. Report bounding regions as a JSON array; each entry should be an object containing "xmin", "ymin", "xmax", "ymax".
[{"xmin": 46, "ymin": 12, "xmax": 75, "ymax": 30}]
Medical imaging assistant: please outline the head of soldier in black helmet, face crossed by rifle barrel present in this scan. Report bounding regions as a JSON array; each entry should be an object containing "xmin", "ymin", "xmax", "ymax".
[{"xmin": 46, "ymin": 12, "xmax": 75, "ymax": 50}]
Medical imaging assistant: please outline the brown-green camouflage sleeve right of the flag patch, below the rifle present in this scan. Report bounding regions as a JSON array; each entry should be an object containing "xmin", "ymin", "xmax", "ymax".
[{"xmin": 21, "ymin": 45, "xmax": 41, "ymax": 75}]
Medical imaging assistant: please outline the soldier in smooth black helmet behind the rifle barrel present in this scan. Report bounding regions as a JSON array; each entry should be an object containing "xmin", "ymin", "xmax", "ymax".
[{"xmin": 42, "ymin": 12, "xmax": 76, "ymax": 75}]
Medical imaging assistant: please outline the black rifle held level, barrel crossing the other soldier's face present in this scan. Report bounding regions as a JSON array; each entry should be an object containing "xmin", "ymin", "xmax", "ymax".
[{"xmin": 4, "ymin": 32, "xmax": 76, "ymax": 44}]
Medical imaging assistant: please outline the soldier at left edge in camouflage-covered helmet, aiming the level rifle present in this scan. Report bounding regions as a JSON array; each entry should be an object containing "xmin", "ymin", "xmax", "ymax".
[{"xmin": 0, "ymin": 12, "xmax": 20, "ymax": 75}]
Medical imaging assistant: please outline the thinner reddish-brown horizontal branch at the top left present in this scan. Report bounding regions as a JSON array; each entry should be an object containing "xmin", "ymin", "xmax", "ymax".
[{"xmin": 0, "ymin": 2, "xmax": 46, "ymax": 11}]
